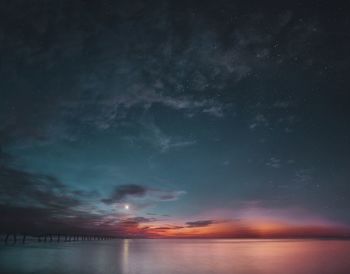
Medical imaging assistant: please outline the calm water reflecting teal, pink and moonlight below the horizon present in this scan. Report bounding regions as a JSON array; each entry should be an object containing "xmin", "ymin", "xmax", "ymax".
[{"xmin": 0, "ymin": 239, "xmax": 350, "ymax": 274}]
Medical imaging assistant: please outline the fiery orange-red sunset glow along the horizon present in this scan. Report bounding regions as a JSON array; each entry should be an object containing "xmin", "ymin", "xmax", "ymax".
[{"xmin": 127, "ymin": 220, "xmax": 350, "ymax": 238}]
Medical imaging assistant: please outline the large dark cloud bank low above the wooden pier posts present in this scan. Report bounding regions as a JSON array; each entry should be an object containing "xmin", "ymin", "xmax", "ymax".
[{"xmin": 0, "ymin": 152, "xmax": 110, "ymax": 234}]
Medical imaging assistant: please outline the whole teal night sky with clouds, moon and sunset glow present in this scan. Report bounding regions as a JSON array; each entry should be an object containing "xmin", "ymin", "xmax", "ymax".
[{"xmin": 0, "ymin": 0, "xmax": 350, "ymax": 237}]
